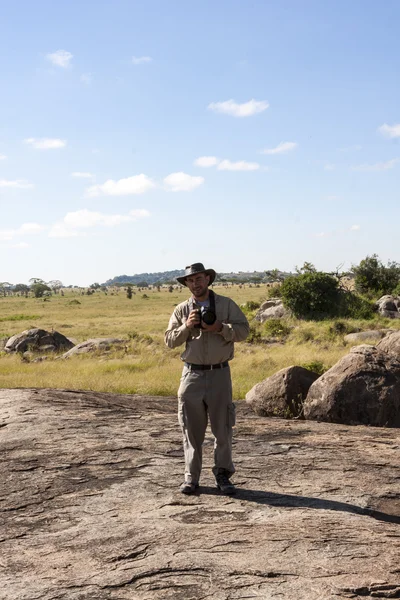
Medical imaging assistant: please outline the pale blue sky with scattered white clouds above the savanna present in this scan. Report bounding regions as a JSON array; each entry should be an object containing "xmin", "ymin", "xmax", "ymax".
[{"xmin": 0, "ymin": 0, "xmax": 400, "ymax": 285}]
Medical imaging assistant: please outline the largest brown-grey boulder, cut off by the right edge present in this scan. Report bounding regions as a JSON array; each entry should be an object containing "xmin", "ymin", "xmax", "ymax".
[{"xmin": 304, "ymin": 345, "xmax": 400, "ymax": 427}]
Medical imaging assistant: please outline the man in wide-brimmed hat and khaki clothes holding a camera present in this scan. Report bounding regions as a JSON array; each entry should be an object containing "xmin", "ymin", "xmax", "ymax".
[{"xmin": 165, "ymin": 263, "xmax": 249, "ymax": 494}]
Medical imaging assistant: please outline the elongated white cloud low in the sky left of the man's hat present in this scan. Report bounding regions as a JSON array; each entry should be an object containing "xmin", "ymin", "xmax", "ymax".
[{"xmin": 49, "ymin": 208, "xmax": 150, "ymax": 238}]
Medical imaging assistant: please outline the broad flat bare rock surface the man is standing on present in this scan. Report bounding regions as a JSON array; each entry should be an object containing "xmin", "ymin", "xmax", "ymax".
[{"xmin": 0, "ymin": 390, "xmax": 400, "ymax": 600}]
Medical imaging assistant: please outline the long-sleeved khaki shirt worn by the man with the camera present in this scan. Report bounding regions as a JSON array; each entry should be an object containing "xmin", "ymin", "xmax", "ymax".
[{"xmin": 165, "ymin": 294, "xmax": 249, "ymax": 365}]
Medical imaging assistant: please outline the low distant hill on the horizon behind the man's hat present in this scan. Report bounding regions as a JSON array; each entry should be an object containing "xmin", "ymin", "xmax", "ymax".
[{"xmin": 102, "ymin": 269, "xmax": 291, "ymax": 286}]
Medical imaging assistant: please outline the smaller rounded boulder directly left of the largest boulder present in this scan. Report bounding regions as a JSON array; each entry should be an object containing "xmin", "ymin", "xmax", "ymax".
[{"xmin": 246, "ymin": 366, "xmax": 319, "ymax": 419}]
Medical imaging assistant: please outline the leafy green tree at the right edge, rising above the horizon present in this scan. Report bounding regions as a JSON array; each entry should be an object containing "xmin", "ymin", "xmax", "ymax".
[{"xmin": 352, "ymin": 254, "xmax": 400, "ymax": 295}]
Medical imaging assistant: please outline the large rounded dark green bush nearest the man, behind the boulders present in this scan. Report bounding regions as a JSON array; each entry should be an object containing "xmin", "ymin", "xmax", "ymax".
[{"xmin": 281, "ymin": 271, "xmax": 340, "ymax": 319}]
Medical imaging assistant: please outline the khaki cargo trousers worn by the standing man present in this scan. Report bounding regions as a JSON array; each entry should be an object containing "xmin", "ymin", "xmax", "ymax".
[{"xmin": 178, "ymin": 366, "xmax": 235, "ymax": 483}]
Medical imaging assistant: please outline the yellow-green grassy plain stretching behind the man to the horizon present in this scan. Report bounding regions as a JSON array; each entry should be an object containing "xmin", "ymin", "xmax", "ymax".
[{"xmin": 0, "ymin": 285, "xmax": 400, "ymax": 399}]
